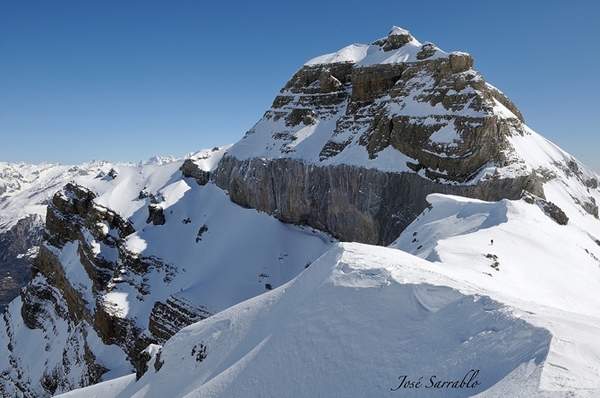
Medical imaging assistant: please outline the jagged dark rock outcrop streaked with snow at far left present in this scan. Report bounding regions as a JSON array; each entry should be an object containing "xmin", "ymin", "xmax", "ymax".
[{"xmin": 6, "ymin": 183, "xmax": 202, "ymax": 396}]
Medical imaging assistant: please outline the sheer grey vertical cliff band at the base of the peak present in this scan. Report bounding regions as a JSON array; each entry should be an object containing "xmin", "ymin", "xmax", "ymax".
[{"xmin": 214, "ymin": 157, "xmax": 543, "ymax": 245}]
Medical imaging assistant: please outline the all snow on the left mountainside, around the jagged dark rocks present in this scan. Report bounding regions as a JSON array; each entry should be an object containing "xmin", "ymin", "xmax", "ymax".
[{"xmin": 0, "ymin": 148, "xmax": 332, "ymax": 396}]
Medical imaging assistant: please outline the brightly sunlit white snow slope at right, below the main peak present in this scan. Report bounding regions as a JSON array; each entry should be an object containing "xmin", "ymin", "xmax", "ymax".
[{"xmin": 391, "ymin": 195, "xmax": 600, "ymax": 397}]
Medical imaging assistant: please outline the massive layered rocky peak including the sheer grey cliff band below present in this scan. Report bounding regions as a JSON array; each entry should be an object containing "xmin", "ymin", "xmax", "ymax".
[{"xmin": 212, "ymin": 28, "xmax": 584, "ymax": 245}]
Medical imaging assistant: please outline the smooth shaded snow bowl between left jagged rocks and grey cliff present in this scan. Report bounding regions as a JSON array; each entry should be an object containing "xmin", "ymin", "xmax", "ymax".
[{"xmin": 75, "ymin": 154, "xmax": 330, "ymax": 327}]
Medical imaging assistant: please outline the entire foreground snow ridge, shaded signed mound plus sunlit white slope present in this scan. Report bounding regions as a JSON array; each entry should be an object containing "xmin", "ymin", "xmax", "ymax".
[{"xmin": 59, "ymin": 190, "xmax": 600, "ymax": 397}]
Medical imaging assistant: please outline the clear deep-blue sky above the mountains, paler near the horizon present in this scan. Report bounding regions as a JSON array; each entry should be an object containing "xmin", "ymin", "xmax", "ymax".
[{"xmin": 0, "ymin": 0, "xmax": 600, "ymax": 172}]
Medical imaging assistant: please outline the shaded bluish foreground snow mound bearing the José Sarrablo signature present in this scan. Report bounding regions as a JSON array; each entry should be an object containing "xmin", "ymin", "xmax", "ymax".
[{"xmin": 57, "ymin": 244, "xmax": 551, "ymax": 397}]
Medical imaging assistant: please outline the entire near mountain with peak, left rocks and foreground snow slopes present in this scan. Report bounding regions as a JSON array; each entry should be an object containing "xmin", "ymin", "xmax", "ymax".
[{"xmin": 0, "ymin": 27, "xmax": 600, "ymax": 398}]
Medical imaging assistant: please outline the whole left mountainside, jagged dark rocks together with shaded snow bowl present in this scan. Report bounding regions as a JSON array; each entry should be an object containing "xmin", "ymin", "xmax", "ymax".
[{"xmin": 0, "ymin": 149, "xmax": 330, "ymax": 397}]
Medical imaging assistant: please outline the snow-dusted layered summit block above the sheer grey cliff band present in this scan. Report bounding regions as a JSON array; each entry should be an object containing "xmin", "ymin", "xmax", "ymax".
[{"xmin": 225, "ymin": 27, "xmax": 502, "ymax": 177}]
